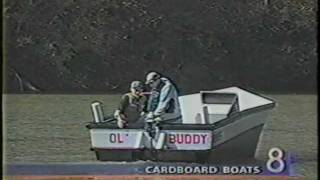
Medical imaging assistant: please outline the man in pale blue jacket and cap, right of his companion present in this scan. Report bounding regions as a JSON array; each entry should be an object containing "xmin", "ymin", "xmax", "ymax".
[{"xmin": 146, "ymin": 72, "xmax": 182, "ymax": 123}]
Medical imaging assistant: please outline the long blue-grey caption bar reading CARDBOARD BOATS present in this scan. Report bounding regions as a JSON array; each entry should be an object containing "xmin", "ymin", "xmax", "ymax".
[{"xmin": 4, "ymin": 162, "xmax": 297, "ymax": 177}]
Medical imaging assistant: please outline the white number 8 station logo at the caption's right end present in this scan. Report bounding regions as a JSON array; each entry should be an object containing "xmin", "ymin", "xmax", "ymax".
[{"xmin": 267, "ymin": 147, "xmax": 285, "ymax": 173}]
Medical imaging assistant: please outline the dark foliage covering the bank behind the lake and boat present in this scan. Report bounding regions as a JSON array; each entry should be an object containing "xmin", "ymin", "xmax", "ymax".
[{"xmin": 4, "ymin": 0, "xmax": 317, "ymax": 93}]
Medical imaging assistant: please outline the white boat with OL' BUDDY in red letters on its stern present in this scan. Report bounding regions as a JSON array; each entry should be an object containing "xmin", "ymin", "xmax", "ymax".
[{"xmin": 86, "ymin": 87, "xmax": 275, "ymax": 163}]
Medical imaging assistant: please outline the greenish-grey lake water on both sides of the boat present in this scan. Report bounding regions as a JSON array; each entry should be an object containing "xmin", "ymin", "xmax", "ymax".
[{"xmin": 3, "ymin": 95, "xmax": 318, "ymax": 179}]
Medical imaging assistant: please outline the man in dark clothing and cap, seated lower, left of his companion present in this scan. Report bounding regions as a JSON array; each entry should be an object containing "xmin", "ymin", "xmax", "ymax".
[{"xmin": 114, "ymin": 81, "xmax": 147, "ymax": 128}]
